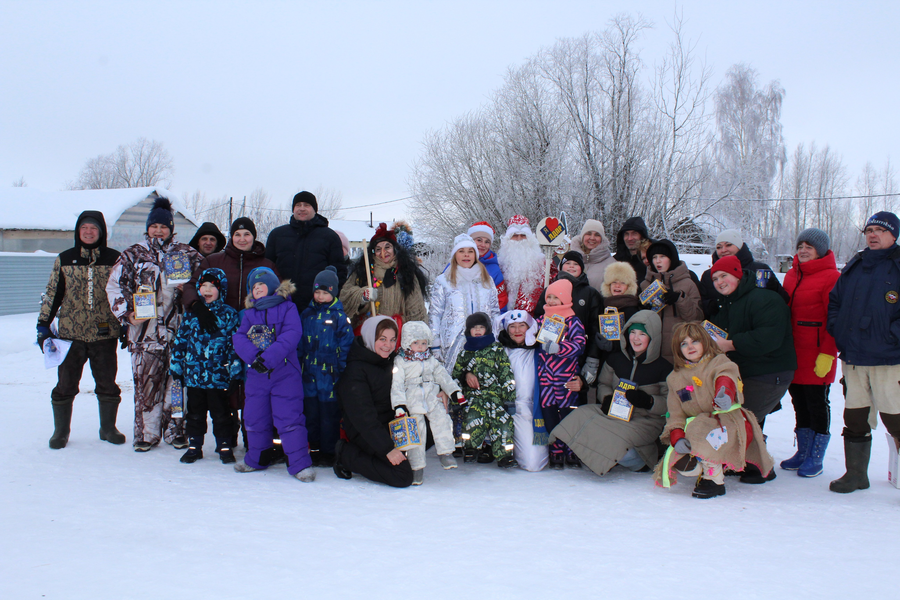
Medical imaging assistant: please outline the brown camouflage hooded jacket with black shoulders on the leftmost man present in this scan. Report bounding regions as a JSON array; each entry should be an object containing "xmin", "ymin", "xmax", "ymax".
[{"xmin": 38, "ymin": 210, "xmax": 121, "ymax": 342}]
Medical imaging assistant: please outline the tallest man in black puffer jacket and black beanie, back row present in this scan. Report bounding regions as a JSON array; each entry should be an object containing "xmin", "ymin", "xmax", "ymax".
[{"xmin": 266, "ymin": 192, "xmax": 347, "ymax": 312}]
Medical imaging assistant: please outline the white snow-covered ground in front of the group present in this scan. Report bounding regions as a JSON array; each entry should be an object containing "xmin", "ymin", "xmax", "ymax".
[{"xmin": 0, "ymin": 314, "xmax": 900, "ymax": 600}]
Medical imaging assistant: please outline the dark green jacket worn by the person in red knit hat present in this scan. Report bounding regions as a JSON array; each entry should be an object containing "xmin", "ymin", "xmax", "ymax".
[{"xmin": 709, "ymin": 271, "xmax": 797, "ymax": 378}]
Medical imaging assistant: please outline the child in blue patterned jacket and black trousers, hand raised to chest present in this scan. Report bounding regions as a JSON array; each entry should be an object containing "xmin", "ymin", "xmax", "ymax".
[{"xmin": 169, "ymin": 269, "xmax": 243, "ymax": 464}]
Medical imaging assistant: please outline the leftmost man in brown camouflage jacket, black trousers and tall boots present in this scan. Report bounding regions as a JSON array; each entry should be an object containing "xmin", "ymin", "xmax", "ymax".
[{"xmin": 37, "ymin": 210, "xmax": 125, "ymax": 450}]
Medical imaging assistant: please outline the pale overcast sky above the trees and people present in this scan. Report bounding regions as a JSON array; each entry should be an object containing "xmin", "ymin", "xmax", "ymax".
[{"xmin": 0, "ymin": 0, "xmax": 900, "ymax": 221}]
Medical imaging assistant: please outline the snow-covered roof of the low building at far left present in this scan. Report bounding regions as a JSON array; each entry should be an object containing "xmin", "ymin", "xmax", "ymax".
[{"xmin": 0, "ymin": 187, "xmax": 198, "ymax": 231}]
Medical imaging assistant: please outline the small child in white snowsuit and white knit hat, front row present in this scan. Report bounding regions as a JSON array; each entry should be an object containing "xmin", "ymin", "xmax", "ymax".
[{"xmin": 391, "ymin": 321, "xmax": 462, "ymax": 485}]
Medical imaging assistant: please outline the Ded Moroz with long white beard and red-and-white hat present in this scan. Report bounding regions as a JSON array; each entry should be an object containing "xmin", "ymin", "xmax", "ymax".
[{"xmin": 497, "ymin": 215, "xmax": 546, "ymax": 313}]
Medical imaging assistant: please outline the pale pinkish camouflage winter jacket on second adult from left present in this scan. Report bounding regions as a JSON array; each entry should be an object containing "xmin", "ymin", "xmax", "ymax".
[{"xmin": 106, "ymin": 234, "xmax": 203, "ymax": 352}]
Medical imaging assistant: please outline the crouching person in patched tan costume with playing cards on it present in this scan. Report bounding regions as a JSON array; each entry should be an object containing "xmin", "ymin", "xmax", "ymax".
[{"xmin": 653, "ymin": 322, "xmax": 774, "ymax": 498}]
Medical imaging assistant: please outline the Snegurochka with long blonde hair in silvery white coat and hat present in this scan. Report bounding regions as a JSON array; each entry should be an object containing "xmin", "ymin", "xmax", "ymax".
[{"xmin": 429, "ymin": 233, "xmax": 500, "ymax": 372}]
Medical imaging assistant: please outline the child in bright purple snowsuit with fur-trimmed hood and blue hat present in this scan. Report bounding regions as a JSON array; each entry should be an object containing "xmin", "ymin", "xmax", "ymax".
[{"xmin": 233, "ymin": 267, "xmax": 316, "ymax": 482}]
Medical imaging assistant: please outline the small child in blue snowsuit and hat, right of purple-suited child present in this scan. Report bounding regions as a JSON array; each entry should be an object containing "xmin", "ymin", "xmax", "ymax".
[{"xmin": 297, "ymin": 266, "xmax": 354, "ymax": 467}]
